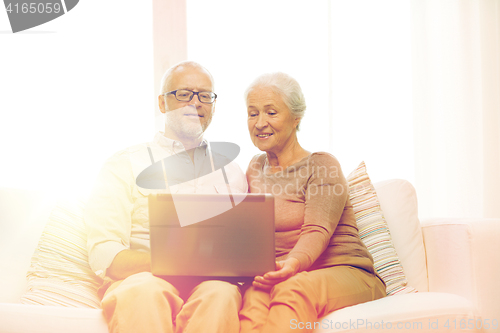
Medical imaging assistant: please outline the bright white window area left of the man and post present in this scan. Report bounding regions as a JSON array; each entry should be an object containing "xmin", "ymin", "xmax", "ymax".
[{"xmin": 0, "ymin": 0, "xmax": 154, "ymax": 196}]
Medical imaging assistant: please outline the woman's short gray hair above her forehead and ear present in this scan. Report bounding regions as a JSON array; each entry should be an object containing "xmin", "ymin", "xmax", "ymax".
[{"xmin": 245, "ymin": 72, "xmax": 306, "ymax": 131}]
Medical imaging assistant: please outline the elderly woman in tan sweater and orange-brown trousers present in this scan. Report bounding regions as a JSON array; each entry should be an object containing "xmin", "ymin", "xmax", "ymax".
[{"xmin": 240, "ymin": 73, "xmax": 386, "ymax": 333}]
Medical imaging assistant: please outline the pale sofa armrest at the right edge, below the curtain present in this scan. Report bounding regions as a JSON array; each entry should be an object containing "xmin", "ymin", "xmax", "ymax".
[{"xmin": 422, "ymin": 218, "xmax": 500, "ymax": 322}]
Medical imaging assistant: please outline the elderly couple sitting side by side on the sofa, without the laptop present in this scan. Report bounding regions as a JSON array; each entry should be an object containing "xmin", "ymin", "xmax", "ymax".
[{"xmin": 85, "ymin": 62, "xmax": 385, "ymax": 333}]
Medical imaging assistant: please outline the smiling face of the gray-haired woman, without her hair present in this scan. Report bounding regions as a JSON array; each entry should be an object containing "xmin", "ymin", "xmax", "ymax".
[{"xmin": 247, "ymin": 87, "xmax": 300, "ymax": 153}]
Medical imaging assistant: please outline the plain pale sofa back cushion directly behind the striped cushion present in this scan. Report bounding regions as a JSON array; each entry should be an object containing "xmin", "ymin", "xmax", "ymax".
[{"xmin": 373, "ymin": 179, "xmax": 428, "ymax": 291}]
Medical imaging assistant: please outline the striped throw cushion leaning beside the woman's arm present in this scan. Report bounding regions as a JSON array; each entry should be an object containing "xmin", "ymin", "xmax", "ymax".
[{"xmin": 347, "ymin": 162, "xmax": 416, "ymax": 295}]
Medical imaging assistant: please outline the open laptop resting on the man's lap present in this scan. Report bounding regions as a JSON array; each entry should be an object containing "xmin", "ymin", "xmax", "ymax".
[{"xmin": 148, "ymin": 193, "xmax": 275, "ymax": 282}]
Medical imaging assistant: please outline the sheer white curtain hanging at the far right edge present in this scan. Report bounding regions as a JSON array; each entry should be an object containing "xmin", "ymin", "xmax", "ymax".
[{"xmin": 412, "ymin": 0, "xmax": 500, "ymax": 218}]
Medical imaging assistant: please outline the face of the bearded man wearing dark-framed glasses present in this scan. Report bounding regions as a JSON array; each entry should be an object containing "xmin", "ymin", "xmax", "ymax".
[{"xmin": 159, "ymin": 66, "xmax": 215, "ymax": 140}]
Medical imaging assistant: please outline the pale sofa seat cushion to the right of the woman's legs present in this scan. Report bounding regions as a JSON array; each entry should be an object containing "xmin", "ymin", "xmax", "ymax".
[{"xmin": 314, "ymin": 292, "xmax": 482, "ymax": 333}]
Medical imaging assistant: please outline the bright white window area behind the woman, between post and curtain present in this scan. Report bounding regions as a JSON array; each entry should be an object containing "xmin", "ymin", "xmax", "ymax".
[{"xmin": 187, "ymin": 0, "xmax": 414, "ymax": 181}]
